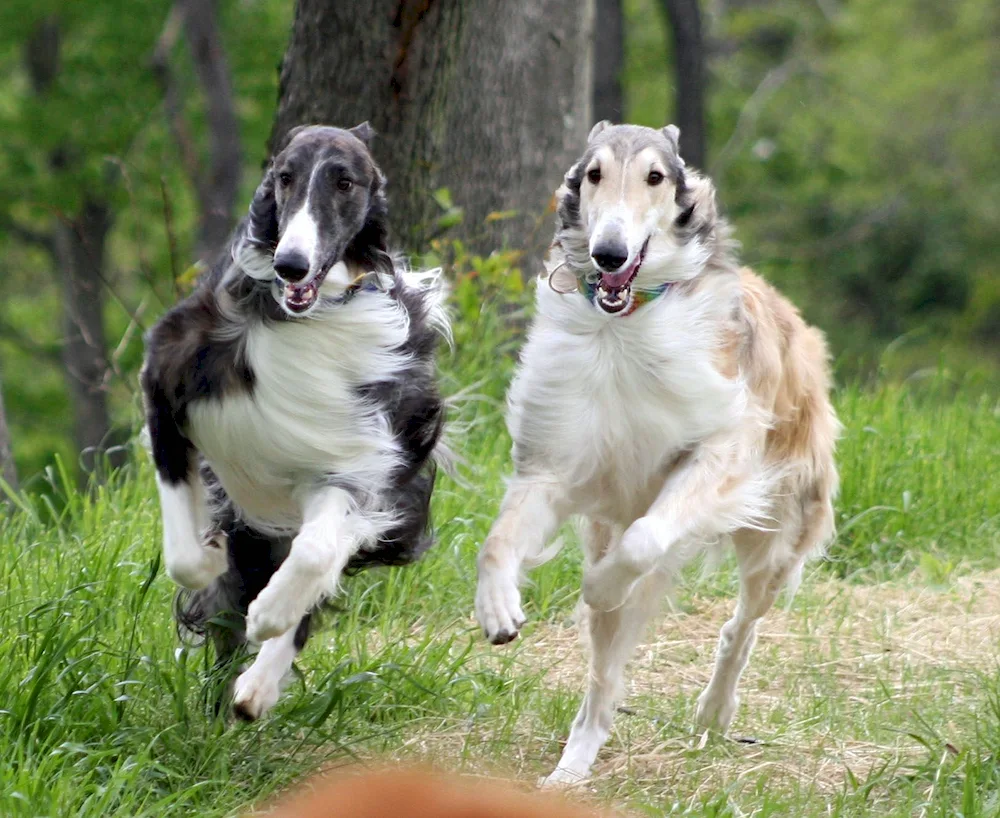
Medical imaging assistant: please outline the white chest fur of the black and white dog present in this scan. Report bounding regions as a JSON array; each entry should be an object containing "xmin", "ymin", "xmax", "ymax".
[{"xmin": 189, "ymin": 292, "xmax": 408, "ymax": 531}]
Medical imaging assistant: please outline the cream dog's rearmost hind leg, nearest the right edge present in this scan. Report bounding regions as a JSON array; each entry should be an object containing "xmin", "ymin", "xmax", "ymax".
[{"xmin": 696, "ymin": 488, "xmax": 833, "ymax": 732}]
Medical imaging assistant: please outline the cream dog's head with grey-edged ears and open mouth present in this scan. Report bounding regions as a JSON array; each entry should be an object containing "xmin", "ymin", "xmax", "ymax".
[{"xmin": 556, "ymin": 121, "xmax": 717, "ymax": 314}]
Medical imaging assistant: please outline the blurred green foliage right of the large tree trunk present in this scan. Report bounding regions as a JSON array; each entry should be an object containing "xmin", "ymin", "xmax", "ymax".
[{"xmin": 625, "ymin": 0, "xmax": 1000, "ymax": 373}]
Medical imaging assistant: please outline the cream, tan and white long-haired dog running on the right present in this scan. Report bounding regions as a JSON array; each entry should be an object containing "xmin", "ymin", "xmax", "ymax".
[{"xmin": 476, "ymin": 122, "xmax": 839, "ymax": 784}]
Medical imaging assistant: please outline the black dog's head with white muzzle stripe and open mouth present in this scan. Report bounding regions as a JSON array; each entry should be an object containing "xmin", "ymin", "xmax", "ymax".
[{"xmin": 242, "ymin": 122, "xmax": 388, "ymax": 316}]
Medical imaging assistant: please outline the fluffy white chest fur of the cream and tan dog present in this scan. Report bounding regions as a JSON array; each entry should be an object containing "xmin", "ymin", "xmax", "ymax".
[{"xmin": 508, "ymin": 281, "xmax": 746, "ymax": 524}]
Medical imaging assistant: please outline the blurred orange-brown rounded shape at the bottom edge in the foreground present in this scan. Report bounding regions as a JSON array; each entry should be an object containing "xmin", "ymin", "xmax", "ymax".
[{"xmin": 256, "ymin": 769, "xmax": 609, "ymax": 818}]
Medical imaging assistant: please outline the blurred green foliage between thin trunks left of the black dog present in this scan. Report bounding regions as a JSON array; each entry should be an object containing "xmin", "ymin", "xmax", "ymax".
[{"xmin": 0, "ymin": 0, "xmax": 293, "ymax": 478}]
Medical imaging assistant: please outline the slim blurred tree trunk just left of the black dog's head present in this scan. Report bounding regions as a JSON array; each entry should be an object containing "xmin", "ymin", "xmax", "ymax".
[{"xmin": 178, "ymin": 0, "xmax": 243, "ymax": 263}]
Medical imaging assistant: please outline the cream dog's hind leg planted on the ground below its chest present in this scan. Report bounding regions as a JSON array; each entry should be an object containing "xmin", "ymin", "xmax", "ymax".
[{"xmin": 543, "ymin": 560, "xmax": 672, "ymax": 787}]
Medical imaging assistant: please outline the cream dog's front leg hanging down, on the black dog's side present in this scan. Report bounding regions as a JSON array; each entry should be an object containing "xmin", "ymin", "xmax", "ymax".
[{"xmin": 476, "ymin": 477, "xmax": 566, "ymax": 645}]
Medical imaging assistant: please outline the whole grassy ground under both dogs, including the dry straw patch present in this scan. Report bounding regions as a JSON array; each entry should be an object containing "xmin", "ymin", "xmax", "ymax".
[{"xmin": 0, "ymin": 317, "xmax": 1000, "ymax": 818}]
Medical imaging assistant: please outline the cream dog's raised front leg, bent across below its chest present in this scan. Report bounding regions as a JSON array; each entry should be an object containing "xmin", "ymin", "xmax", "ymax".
[{"xmin": 583, "ymin": 438, "xmax": 770, "ymax": 611}]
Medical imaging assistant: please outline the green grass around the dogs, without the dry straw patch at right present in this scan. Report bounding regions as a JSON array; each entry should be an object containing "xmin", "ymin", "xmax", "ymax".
[{"xmin": 0, "ymin": 313, "xmax": 1000, "ymax": 818}]
